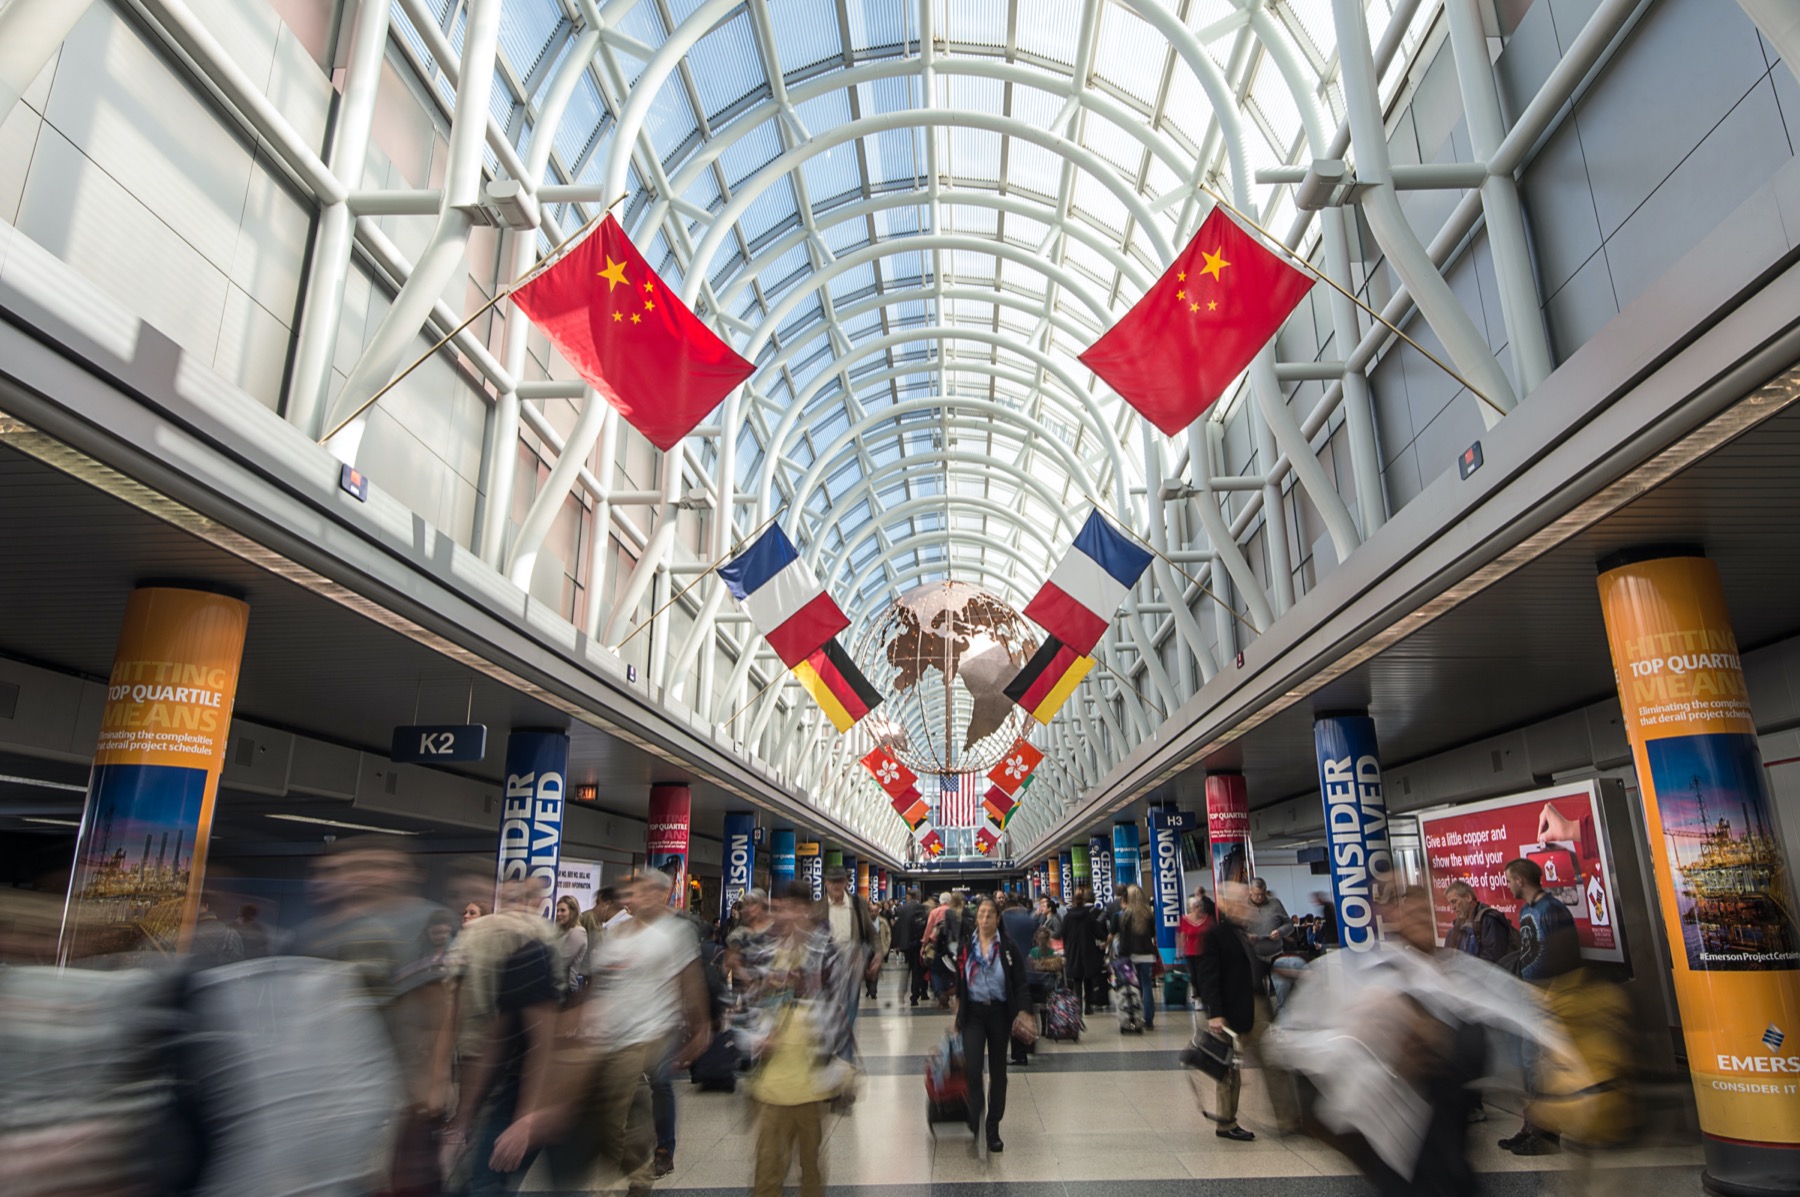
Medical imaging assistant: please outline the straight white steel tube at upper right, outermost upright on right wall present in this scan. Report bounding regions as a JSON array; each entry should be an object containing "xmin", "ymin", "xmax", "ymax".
[{"xmin": 1444, "ymin": 0, "xmax": 1555, "ymax": 396}]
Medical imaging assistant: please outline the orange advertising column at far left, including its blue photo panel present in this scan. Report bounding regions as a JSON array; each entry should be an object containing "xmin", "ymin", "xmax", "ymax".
[{"xmin": 59, "ymin": 587, "xmax": 250, "ymax": 963}]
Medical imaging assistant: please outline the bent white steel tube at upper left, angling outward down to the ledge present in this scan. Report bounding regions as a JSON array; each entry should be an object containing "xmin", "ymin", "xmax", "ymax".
[{"xmin": 326, "ymin": 0, "xmax": 504, "ymax": 463}]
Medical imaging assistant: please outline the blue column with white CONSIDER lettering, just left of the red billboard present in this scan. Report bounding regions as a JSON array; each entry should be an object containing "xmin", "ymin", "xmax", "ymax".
[{"xmin": 1312, "ymin": 715, "xmax": 1393, "ymax": 952}]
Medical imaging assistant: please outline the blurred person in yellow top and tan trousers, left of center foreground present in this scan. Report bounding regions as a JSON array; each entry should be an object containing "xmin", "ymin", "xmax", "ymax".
[{"xmin": 749, "ymin": 882, "xmax": 857, "ymax": 1197}]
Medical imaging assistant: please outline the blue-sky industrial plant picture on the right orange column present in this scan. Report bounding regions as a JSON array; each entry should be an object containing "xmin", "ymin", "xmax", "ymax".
[{"xmin": 1643, "ymin": 734, "xmax": 1800, "ymax": 972}]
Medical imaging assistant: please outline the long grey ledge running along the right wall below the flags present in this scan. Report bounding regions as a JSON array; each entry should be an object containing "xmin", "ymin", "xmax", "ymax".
[{"xmin": 1026, "ymin": 243, "xmax": 1800, "ymax": 855}]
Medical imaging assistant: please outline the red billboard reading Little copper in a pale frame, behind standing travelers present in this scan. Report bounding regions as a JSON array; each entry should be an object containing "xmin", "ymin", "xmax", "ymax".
[{"xmin": 1418, "ymin": 781, "xmax": 1625, "ymax": 961}]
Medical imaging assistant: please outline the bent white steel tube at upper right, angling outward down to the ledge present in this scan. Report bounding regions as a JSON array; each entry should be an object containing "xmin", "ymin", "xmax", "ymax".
[{"xmin": 1332, "ymin": 0, "xmax": 1517, "ymax": 428}]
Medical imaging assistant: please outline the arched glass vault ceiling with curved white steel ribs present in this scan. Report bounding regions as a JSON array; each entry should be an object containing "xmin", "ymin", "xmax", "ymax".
[{"xmin": 396, "ymin": 0, "xmax": 1438, "ymax": 617}]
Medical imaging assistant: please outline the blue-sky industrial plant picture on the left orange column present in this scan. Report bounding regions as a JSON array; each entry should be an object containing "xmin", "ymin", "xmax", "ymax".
[{"xmin": 68, "ymin": 765, "xmax": 207, "ymax": 956}]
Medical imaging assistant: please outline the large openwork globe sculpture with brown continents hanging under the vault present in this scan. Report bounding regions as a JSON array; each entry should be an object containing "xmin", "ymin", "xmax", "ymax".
[{"xmin": 853, "ymin": 581, "xmax": 1037, "ymax": 774}]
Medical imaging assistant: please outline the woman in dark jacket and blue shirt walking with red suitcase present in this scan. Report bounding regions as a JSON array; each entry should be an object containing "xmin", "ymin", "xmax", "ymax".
[{"xmin": 956, "ymin": 898, "xmax": 1031, "ymax": 1152}]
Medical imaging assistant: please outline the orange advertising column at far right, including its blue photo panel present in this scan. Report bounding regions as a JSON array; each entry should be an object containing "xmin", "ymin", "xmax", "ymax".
[{"xmin": 1600, "ymin": 547, "xmax": 1800, "ymax": 1193}]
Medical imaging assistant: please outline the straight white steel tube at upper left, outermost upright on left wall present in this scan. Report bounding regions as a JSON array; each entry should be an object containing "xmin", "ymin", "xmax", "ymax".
[{"xmin": 286, "ymin": 0, "xmax": 394, "ymax": 439}]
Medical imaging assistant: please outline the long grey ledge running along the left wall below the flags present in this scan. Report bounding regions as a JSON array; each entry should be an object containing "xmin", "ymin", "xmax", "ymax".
[{"xmin": 0, "ymin": 304, "xmax": 898, "ymax": 864}]
